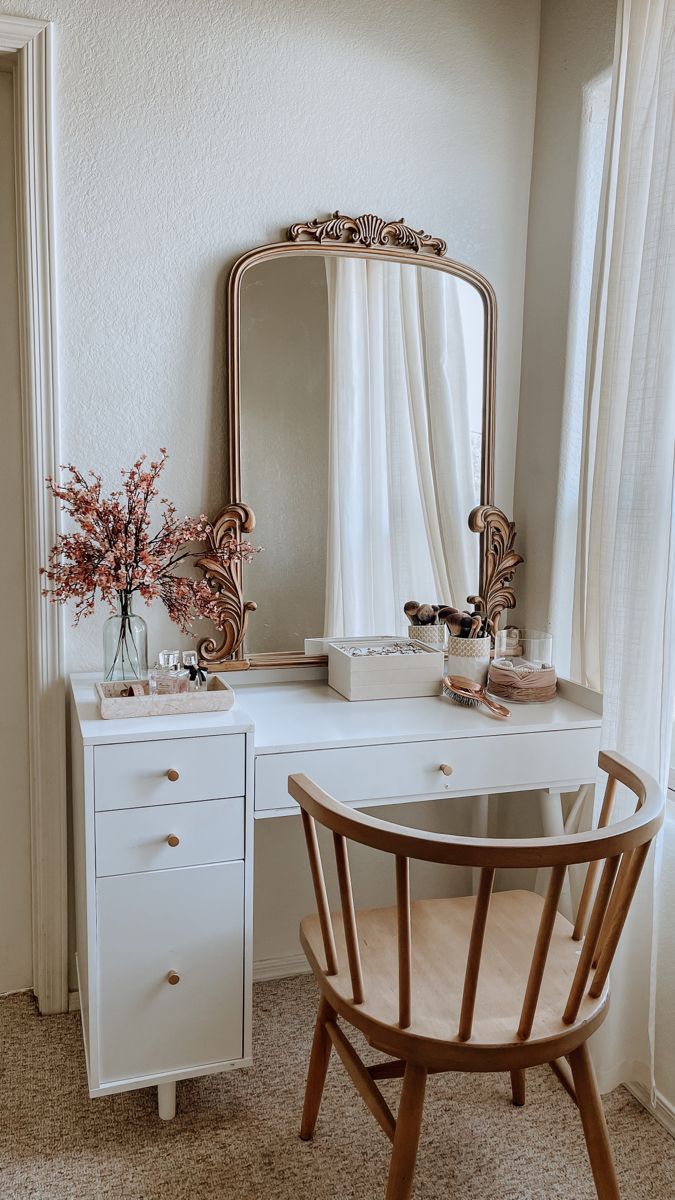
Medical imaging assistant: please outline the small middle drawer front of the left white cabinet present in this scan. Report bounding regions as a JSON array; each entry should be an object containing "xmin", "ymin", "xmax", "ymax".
[{"xmin": 96, "ymin": 796, "xmax": 244, "ymax": 876}]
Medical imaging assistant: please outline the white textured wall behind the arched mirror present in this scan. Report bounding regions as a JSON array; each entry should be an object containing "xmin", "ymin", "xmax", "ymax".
[{"xmin": 2, "ymin": 0, "xmax": 539, "ymax": 668}]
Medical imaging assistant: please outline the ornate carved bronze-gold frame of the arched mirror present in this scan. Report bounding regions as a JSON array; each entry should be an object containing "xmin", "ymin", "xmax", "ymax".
[{"xmin": 197, "ymin": 212, "xmax": 522, "ymax": 671}]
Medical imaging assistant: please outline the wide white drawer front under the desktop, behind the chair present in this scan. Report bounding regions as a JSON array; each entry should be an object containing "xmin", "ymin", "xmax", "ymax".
[{"xmin": 256, "ymin": 728, "xmax": 599, "ymax": 811}]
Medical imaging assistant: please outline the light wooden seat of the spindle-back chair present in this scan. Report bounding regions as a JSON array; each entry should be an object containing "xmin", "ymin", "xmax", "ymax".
[{"xmin": 300, "ymin": 890, "xmax": 608, "ymax": 1069}]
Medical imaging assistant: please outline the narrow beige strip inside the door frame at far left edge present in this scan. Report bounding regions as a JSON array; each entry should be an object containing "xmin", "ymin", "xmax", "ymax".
[{"xmin": 0, "ymin": 61, "xmax": 32, "ymax": 994}]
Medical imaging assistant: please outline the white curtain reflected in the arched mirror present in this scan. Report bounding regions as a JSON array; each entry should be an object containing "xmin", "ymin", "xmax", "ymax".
[{"xmin": 324, "ymin": 257, "xmax": 478, "ymax": 636}]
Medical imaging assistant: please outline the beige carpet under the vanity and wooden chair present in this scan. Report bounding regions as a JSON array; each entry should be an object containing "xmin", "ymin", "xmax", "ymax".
[{"xmin": 0, "ymin": 977, "xmax": 675, "ymax": 1200}]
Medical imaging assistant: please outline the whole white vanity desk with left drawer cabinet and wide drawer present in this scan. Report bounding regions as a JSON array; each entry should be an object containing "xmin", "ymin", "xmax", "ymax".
[{"xmin": 71, "ymin": 668, "xmax": 601, "ymax": 1117}]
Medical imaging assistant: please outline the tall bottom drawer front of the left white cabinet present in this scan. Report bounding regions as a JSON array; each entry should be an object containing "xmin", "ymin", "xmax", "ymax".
[{"xmin": 96, "ymin": 863, "xmax": 244, "ymax": 1084}]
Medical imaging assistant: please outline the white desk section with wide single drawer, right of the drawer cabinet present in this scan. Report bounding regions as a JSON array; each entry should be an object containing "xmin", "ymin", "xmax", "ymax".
[{"xmin": 238, "ymin": 668, "xmax": 601, "ymax": 833}]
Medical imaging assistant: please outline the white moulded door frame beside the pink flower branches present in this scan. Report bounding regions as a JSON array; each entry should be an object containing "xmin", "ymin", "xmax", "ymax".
[{"xmin": 0, "ymin": 14, "xmax": 68, "ymax": 1013}]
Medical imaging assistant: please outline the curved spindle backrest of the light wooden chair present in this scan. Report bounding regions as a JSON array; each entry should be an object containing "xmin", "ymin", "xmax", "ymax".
[{"xmin": 288, "ymin": 751, "xmax": 664, "ymax": 1040}]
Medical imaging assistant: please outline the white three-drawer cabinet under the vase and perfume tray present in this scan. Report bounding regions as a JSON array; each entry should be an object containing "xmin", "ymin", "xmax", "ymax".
[{"xmin": 71, "ymin": 677, "xmax": 253, "ymax": 1118}]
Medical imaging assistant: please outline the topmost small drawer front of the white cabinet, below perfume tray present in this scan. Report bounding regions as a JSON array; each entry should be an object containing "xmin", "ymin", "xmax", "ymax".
[{"xmin": 94, "ymin": 733, "xmax": 245, "ymax": 810}]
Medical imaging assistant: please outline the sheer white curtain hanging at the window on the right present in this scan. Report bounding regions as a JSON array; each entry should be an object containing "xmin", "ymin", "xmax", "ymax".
[{"xmin": 558, "ymin": 0, "xmax": 675, "ymax": 1091}]
